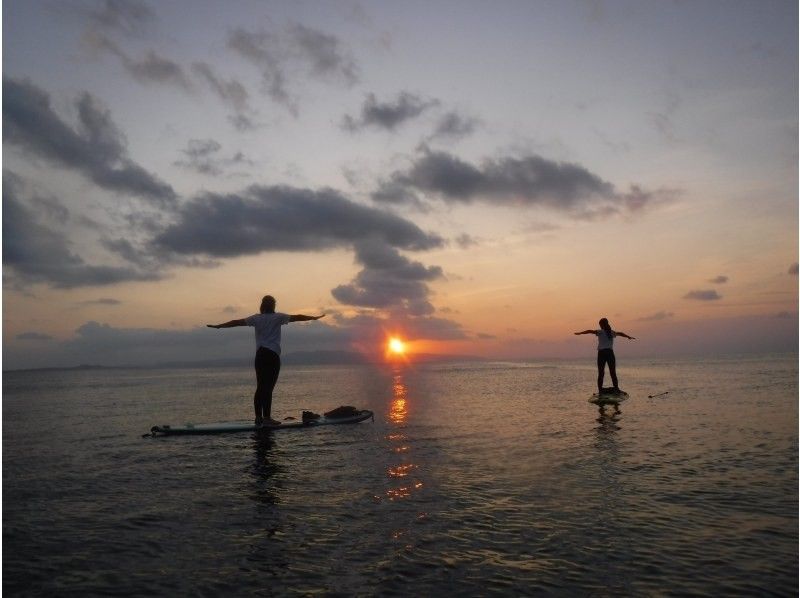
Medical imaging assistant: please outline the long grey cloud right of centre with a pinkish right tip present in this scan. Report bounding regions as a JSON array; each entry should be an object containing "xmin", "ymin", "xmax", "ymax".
[{"xmin": 372, "ymin": 147, "xmax": 675, "ymax": 218}]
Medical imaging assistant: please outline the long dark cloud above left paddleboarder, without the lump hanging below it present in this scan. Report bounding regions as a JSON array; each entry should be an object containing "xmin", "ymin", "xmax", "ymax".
[{"xmin": 154, "ymin": 185, "xmax": 443, "ymax": 257}]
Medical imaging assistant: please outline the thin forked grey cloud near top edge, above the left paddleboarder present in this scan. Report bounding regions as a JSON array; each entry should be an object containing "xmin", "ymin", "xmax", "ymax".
[{"xmin": 228, "ymin": 24, "xmax": 358, "ymax": 116}]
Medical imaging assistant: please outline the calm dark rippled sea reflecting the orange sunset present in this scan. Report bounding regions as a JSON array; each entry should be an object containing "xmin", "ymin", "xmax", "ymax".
[{"xmin": 3, "ymin": 356, "xmax": 798, "ymax": 596}]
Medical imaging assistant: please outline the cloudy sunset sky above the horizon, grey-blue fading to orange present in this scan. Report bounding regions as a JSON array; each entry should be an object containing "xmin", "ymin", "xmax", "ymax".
[{"xmin": 2, "ymin": 0, "xmax": 798, "ymax": 369}]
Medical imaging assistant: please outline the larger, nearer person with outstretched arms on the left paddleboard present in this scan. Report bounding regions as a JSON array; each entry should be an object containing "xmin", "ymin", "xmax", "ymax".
[{"xmin": 207, "ymin": 295, "xmax": 325, "ymax": 426}]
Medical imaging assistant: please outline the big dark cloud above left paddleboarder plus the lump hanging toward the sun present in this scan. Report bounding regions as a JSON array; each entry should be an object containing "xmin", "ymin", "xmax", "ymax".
[{"xmin": 153, "ymin": 186, "xmax": 444, "ymax": 316}]
